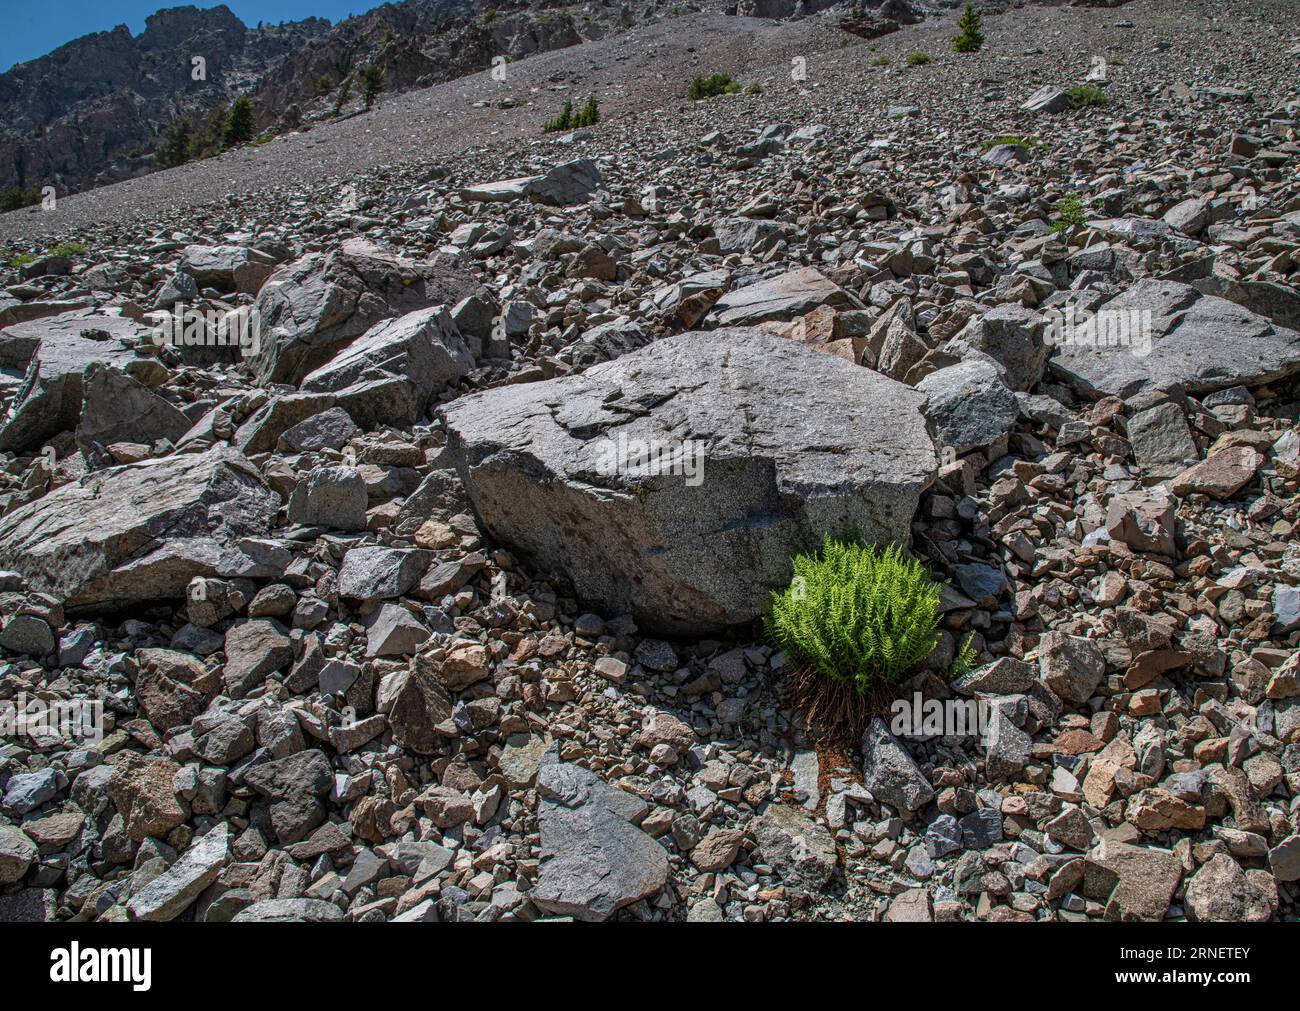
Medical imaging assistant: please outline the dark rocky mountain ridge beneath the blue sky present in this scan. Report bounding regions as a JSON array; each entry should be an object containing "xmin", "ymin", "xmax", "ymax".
[{"xmin": 0, "ymin": 0, "xmax": 686, "ymax": 196}]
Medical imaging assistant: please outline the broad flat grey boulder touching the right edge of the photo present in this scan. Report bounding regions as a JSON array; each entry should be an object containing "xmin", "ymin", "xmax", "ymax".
[{"xmin": 1050, "ymin": 278, "xmax": 1300, "ymax": 396}]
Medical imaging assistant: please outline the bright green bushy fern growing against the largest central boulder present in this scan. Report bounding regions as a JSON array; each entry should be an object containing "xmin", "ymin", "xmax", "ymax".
[{"xmin": 766, "ymin": 537, "xmax": 940, "ymax": 695}]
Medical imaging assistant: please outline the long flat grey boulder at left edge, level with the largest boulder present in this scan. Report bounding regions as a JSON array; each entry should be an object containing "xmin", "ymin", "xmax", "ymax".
[{"xmin": 0, "ymin": 448, "xmax": 280, "ymax": 611}]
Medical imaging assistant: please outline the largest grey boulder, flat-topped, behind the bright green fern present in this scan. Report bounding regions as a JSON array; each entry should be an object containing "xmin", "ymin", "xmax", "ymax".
[{"xmin": 445, "ymin": 329, "xmax": 936, "ymax": 634}]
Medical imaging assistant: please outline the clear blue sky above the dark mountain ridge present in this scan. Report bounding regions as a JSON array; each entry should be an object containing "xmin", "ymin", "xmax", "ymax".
[{"xmin": 0, "ymin": 0, "xmax": 366, "ymax": 73}]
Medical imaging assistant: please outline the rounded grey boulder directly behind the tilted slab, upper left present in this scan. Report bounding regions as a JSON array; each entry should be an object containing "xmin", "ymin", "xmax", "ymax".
[{"xmin": 247, "ymin": 239, "xmax": 485, "ymax": 386}]
